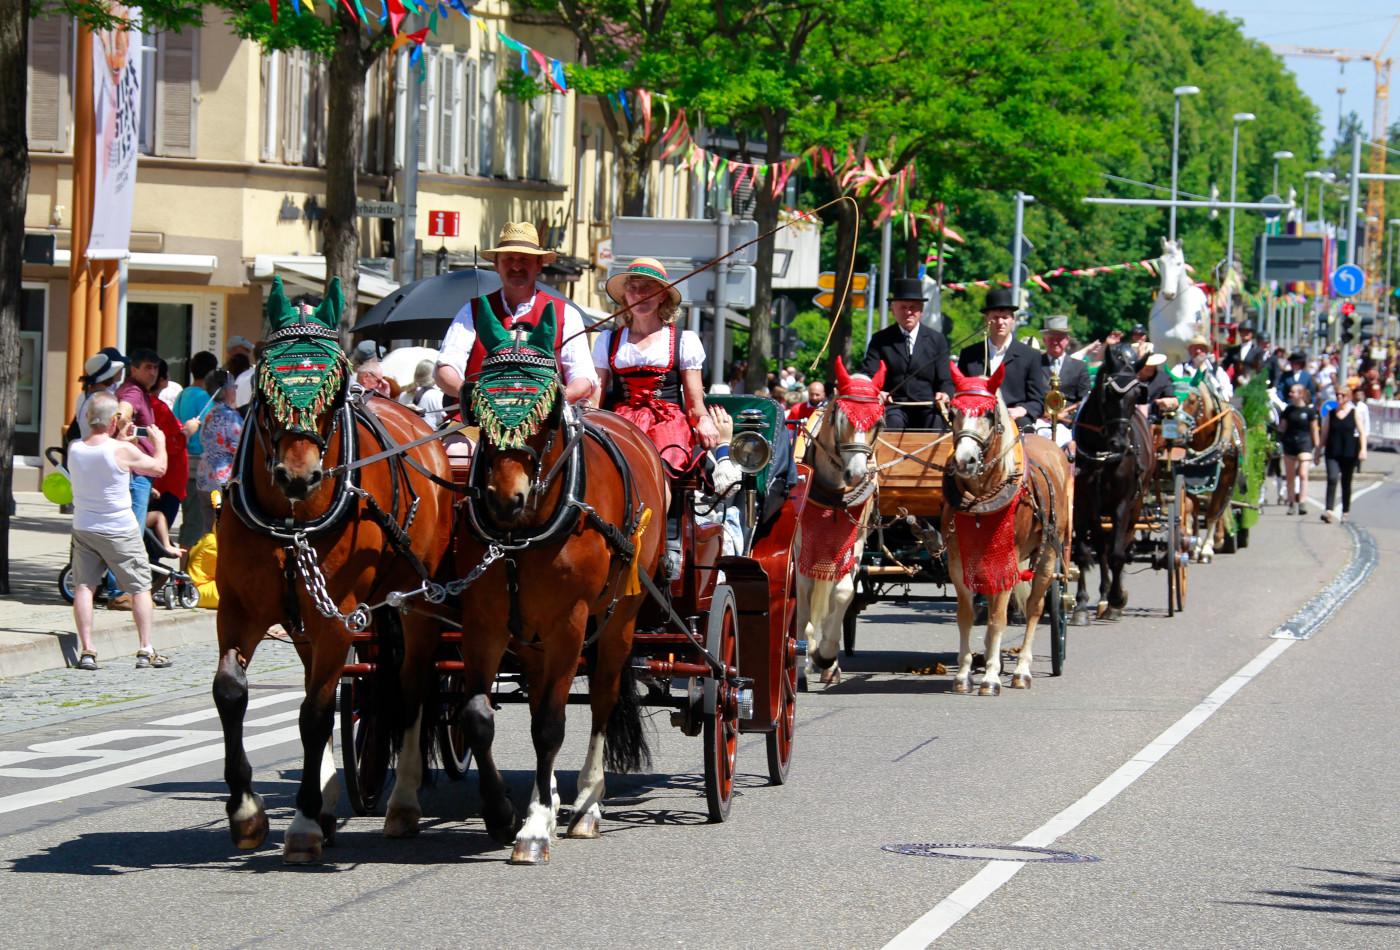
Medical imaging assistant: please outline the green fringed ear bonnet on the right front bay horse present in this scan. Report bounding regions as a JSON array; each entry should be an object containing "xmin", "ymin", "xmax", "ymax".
[{"xmin": 472, "ymin": 297, "xmax": 559, "ymax": 449}]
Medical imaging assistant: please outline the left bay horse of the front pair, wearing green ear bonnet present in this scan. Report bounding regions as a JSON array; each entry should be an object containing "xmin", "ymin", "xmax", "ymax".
[{"xmin": 214, "ymin": 281, "xmax": 452, "ymax": 863}]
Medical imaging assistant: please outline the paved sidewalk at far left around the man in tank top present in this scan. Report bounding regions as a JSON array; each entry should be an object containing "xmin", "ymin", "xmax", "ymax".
[{"xmin": 0, "ymin": 491, "xmax": 216, "ymax": 679}]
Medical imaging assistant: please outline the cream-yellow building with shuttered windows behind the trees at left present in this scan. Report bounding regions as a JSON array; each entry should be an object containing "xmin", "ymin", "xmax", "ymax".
[{"xmin": 15, "ymin": 7, "xmax": 700, "ymax": 490}]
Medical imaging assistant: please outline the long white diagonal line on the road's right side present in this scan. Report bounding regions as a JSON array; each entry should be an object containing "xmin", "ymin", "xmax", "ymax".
[{"xmin": 885, "ymin": 500, "xmax": 1385, "ymax": 950}]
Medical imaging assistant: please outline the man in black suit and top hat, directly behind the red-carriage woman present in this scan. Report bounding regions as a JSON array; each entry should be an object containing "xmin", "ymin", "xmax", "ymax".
[{"xmin": 861, "ymin": 277, "xmax": 953, "ymax": 430}]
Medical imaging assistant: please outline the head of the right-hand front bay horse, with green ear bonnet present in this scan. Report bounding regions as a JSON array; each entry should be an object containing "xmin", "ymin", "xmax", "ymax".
[{"xmin": 472, "ymin": 304, "xmax": 564, "ymax": 529}]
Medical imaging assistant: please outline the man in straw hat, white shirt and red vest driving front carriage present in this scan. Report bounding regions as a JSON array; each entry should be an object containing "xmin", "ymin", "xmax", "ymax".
[{"xmin": 437, "ymin": 221, "xmax": 598, "ymax": 404}]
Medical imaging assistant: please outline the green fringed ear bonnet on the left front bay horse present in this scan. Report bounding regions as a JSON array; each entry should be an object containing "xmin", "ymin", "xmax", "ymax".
[{"xmin": 255, "ymin": 277, "xmax": 350, "ymax": 434}]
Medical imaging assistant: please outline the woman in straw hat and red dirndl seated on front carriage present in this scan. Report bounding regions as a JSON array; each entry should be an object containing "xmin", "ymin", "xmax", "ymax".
[{"xmin": 594, "ymin": 257, "xmax": 720, "ymax": 477}]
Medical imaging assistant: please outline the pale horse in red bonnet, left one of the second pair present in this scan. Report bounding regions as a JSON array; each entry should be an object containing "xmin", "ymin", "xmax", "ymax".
[{"xmin": 797, "ymin": 358, "xmax": 885, "ymax": 684}]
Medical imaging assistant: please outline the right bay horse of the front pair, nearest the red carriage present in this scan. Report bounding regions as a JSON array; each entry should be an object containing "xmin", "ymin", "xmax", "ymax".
[{"xmin": 428, "ymin": 300, "xmax": 666, "ymax": 865}]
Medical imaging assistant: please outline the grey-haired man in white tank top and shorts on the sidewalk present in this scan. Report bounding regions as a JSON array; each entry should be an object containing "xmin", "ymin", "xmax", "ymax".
[{"xmin": 69, "ymin": 392, "xmax": 171, "ymax": 670}]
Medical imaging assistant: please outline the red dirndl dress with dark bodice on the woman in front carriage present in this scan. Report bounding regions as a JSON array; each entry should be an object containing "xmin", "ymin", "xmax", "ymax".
[{"xmin": 605, "ymin": 325, "xmax": 700, "ymax": 474}]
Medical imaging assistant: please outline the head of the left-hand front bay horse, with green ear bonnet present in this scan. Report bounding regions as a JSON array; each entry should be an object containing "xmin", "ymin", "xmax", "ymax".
[{"xmin": 253, "ymin": 278, "xmax": 350, "ymax": 502}]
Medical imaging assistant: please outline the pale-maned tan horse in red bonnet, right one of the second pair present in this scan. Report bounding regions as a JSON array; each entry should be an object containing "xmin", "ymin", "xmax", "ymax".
[{"xmin": 942, "ymin": 362, "xmax": 1071, "ymax": 695}]
